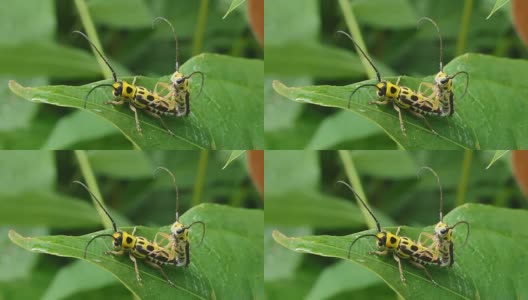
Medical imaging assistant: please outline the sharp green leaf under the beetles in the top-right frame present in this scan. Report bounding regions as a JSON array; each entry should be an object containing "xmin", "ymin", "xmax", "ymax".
[{"xmin": 274, "ymin": 54, "xmax": 528, "ymax": 150}]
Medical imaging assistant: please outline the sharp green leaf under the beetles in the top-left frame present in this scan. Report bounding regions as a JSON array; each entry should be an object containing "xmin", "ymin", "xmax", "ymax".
[{"xmin": 9, "ymin": 54, "xmax": 264, "ymax": 149}]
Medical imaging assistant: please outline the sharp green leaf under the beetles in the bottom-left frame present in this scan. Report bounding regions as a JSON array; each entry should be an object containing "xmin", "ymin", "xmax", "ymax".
[{"xmin": 9, "ymin": 204, "xmax": 264, "ymax": 299}]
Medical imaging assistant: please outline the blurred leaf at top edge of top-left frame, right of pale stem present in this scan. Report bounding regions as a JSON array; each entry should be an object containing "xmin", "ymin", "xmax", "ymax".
[{"xmin": 87, "ymin": 0, "xmax": 153, "ymax": 29}]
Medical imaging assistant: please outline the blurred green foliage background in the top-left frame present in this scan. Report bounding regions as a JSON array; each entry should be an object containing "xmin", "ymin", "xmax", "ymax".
[{"xmin": 0, "ymin": 0, "xmax": 263, "ymax": 149}]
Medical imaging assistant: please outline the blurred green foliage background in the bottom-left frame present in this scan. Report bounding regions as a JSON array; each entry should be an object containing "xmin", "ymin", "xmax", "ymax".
[{"xmin": 0, "ymin": 151, "xmax": 263, "ymax": 300}]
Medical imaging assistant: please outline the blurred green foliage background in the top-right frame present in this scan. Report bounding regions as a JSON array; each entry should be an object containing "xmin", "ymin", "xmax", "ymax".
[{"xmin": 264, "ymin": 0, "xmax": 528, "ymax": 149}]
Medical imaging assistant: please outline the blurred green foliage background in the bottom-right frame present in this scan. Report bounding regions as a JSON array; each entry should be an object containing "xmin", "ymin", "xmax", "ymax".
[{"xmin": 264, "ymin": 150, "xmax": 528, "ymax": 300}]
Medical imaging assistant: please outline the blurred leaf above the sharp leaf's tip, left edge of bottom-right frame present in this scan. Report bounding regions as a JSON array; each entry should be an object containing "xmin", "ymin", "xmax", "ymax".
[{"xmin": 265, "ymin": 192, "xmax": 363, "ymax": 228}]
